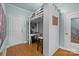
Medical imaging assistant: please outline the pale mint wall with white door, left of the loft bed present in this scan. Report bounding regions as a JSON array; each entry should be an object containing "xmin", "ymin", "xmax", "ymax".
[{"xmin": 1, "ymin": 4, "xmax": 32, "ymax": 50}]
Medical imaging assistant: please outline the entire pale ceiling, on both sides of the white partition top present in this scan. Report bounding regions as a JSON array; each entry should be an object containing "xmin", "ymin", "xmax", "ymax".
[{"xmin": 10, "ymin": 3, "xmax": 79, "ymax": 13}]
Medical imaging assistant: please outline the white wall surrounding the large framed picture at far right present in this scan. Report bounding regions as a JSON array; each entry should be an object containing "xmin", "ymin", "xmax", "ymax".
[{"xmin": 64, "ymin": 11, "xmax": 79, "ymax": 54}]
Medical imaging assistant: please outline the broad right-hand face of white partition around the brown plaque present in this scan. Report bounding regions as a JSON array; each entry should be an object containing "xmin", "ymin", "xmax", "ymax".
[{"xmin": 49, "ymin": 5, "xmax": 59, "ymax": 55}]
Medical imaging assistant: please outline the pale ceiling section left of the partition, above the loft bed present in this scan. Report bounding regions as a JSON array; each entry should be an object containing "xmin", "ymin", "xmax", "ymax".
[{"xmin": 10, "ymin": 3, "xmax": 43, "ymax": 12}]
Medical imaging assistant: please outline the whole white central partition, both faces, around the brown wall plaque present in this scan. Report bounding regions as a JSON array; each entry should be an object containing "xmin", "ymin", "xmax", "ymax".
[{"xmin": 43, "ymin": 4, "xmax": 59, "ymax": 55}]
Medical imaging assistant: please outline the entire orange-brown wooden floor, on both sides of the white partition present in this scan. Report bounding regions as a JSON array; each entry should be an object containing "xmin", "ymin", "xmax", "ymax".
[{"xmin": 7, "ymin": 43, "xmax": 79, "ymax": 56}]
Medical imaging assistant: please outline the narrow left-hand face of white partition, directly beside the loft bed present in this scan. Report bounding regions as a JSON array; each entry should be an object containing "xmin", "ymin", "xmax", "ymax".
[{"xmin": 43, "ymin": 4, "xmax": 49, "ymax": 56}]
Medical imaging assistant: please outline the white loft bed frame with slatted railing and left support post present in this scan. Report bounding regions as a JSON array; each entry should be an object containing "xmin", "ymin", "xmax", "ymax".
[{"xmin": 29, "ymin": 7, "xmax": 43, "ymax": 44}]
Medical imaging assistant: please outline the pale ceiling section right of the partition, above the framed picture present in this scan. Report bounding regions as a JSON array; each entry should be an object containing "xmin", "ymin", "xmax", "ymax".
[{"xmin": 55, "ymin": 3, "xmax": 79, "ymax": 13}]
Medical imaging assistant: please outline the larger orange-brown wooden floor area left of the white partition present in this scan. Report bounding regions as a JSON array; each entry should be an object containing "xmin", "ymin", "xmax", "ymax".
[{"xmin": 7, "ymin": 43, "xmax": 42, "ymax": 56}]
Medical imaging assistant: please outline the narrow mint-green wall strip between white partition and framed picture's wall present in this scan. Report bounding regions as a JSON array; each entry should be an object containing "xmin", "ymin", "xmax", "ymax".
[{"xmin": 59, "ymin": 13, "xmax": 64, "ymax": 47}]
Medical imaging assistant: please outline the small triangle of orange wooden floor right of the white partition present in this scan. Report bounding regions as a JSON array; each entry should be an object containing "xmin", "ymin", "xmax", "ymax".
[{"xmin": 53, "ymin": 48, "xmax": 79, "ymax": 56}]
